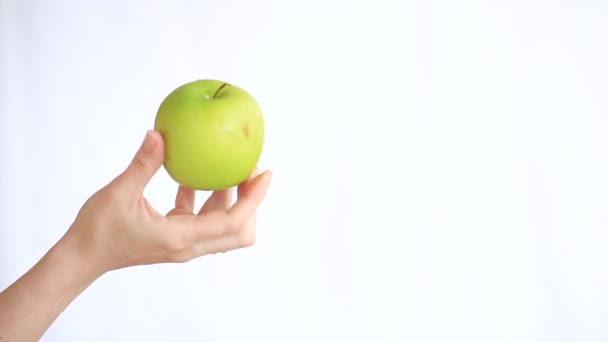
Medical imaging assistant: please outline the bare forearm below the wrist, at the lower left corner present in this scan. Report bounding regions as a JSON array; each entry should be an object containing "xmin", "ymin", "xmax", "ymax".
[{"xmin": 0, "ymin": 232, "xmax": 101, "ymax": 342}]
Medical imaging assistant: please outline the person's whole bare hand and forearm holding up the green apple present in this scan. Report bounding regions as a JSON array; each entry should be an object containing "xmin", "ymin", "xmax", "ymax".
[{"xmin": 0, "ymin": 131, "xmax": 271, "ymax": 341}]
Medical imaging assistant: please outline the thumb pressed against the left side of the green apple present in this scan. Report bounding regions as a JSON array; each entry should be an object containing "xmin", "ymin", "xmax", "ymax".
[{"xmin": 121, "ymin": 130, "xmax": 165, "ymax": 193}]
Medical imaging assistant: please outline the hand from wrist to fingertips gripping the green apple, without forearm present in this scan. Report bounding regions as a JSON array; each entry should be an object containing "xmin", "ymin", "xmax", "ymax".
[{"xmin": 62, "ymin": 131, "xmax": 271, "ymax": 274}]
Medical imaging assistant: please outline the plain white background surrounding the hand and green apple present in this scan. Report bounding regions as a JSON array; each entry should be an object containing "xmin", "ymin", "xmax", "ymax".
[{"xmin": 0, "ymin": 0, "xmax": 608, "ymax": 342}]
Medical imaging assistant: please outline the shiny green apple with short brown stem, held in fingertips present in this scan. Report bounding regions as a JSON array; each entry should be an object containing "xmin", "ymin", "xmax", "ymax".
[{"xmin": 154, "ymin": 79, "xmax": 264, "ymax": 190}]
